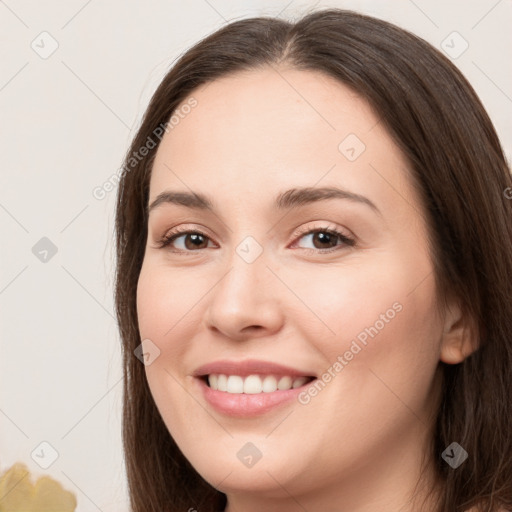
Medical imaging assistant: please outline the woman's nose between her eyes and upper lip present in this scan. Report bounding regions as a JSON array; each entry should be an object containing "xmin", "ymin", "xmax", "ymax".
[{"xmin": 205, "ymin": 246, "xmax": 284, "ymax": 341}]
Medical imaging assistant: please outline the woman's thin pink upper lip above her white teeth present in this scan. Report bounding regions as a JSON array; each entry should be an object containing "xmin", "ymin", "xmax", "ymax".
[{"xmin": 194, "ymin": 359, "xmax": 315, "ymax": 377}]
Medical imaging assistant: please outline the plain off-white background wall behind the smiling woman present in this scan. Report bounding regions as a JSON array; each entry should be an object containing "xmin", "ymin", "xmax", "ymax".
[{"xmin": 0, "ymin": 0, "xmax": 512, "ymax": 512}]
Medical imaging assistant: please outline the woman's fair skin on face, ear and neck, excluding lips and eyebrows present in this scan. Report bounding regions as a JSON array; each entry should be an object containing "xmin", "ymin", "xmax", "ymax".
[{"xmin": 137, "ymin": 66, "xmax": 472, "ymax": 512}]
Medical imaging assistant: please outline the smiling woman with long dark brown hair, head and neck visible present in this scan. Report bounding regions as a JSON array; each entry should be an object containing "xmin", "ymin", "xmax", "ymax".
[{"xmin": 116, "ymin": 9, "xmax": 512, "ymax": 512}]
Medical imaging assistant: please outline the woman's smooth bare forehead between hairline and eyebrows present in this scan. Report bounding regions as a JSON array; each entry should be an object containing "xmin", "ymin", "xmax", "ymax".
[{"xmin": 150, "ymin": 67, "xmax": 424, "ymax": 224}]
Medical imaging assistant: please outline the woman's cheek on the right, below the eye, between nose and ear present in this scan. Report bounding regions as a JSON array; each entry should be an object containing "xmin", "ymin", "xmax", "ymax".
[{"xmin": 293, "ymin": 252, "xmax": 440, "ymax": 373}]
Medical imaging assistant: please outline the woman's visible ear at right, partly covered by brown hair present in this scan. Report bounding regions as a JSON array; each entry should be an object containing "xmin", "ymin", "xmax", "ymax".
[{"xmin": 439, "ymin": 303, "xmax": 478, "ymax": 364}]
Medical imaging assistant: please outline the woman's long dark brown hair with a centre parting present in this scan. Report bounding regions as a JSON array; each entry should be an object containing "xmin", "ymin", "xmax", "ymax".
[{"xmin": 115, "ymin": 8, "xmax": 512, "ymax": 512}]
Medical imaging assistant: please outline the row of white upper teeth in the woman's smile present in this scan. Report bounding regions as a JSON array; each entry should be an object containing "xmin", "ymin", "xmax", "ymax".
[{"xmin": 208, "ymin": 374, "xmax": 308, "ymax": 395}]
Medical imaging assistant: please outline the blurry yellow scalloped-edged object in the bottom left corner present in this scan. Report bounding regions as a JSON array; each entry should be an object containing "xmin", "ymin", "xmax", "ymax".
[{"xmin": 0, "ymin": 462, "xmax": 77, "ymax": 512}]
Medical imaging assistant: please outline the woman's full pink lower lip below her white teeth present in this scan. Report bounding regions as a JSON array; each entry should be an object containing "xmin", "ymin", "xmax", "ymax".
[{"xmin": 197, "ymin": 378, "xmax": 314, "ymax": 418}]
